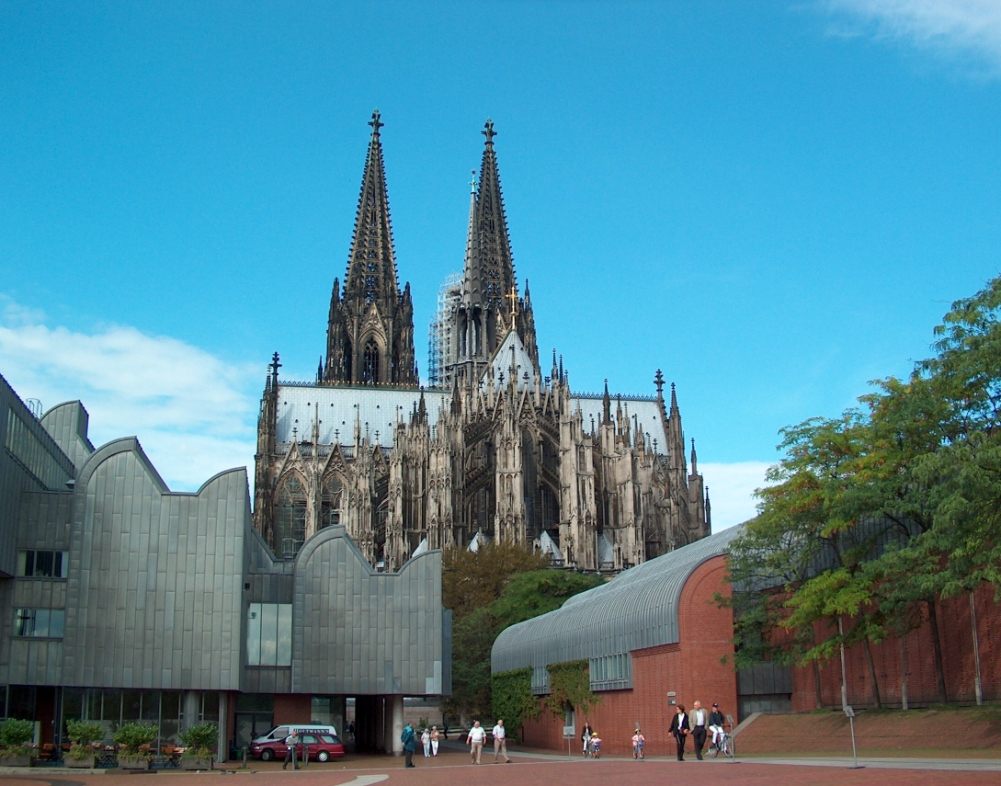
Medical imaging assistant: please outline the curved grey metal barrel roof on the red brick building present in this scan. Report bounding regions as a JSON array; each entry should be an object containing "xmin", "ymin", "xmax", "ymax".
[{"xmin": 490, "ymin": 527, "xmax": 741, "ymax": 673}]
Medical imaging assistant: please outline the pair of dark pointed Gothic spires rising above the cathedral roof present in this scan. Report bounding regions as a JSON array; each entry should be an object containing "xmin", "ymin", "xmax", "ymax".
[{"xmin": 317, "ymin": 110, "xmax": 539, "ymax": 386}]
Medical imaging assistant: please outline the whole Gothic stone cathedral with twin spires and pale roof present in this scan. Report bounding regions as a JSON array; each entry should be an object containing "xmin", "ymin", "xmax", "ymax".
[{"xmin": 253, "ymin": 112, "xmax": 711, "ymax": 571}]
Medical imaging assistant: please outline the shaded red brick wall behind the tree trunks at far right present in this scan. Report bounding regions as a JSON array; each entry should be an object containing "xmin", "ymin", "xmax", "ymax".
[{"xmin": 793, "ymin": 587, "xmax": 1001, "ymax": 711}]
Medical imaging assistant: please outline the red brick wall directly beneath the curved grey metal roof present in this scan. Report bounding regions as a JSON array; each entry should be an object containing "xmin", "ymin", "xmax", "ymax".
[{"xmin": 525, "ymin": 557, "xmax": 737, "ymax": 756}]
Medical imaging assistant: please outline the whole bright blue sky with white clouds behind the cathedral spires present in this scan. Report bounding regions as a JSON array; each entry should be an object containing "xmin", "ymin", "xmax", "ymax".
[{"xmin": 0, "ymin": 0, "xmax": 1001, "ymax": 529}]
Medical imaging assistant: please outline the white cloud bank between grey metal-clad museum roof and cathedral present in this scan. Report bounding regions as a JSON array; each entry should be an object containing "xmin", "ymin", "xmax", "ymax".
[{"xmin": 0, "ymin": 296, "xmax": 259, "ymax": 491}]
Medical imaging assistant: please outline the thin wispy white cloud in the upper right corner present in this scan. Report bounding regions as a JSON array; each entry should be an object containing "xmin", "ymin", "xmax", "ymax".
[{"xmin": 820, "ymin": 0, "xmax": 1001, "ymax": 78}]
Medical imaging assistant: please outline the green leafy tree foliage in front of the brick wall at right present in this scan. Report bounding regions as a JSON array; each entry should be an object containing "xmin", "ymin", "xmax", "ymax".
[{"xmin": 729, "ymin": 278, "xmax": 1001, "ymax": 702}]
